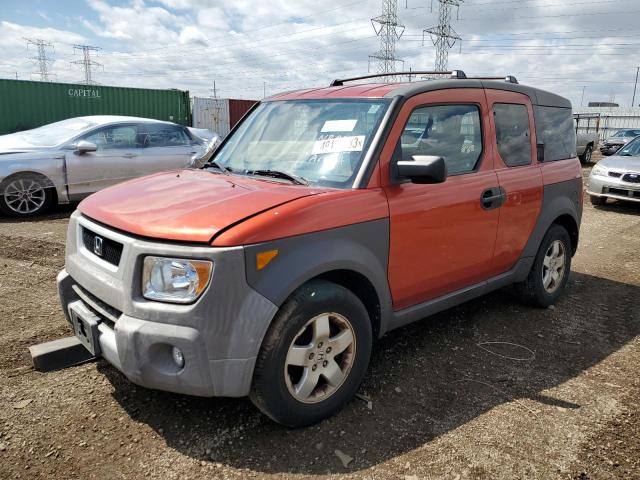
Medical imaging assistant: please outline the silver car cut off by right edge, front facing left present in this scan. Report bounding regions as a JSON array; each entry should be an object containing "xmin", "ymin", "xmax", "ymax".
[{"xmin": 587, "ymin": 137, "xmax": 640, "ymax": 205}]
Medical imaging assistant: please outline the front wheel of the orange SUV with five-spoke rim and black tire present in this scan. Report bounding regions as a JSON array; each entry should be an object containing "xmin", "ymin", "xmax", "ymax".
[{"xmin": 250, "ymin": 280, "xmax": 372, "ymax": 427}]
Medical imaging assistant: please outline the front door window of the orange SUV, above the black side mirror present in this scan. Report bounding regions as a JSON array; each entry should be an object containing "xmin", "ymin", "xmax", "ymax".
[{"xmin": 400, "ymin": 105, "xmax": 482, "ymax": 175}]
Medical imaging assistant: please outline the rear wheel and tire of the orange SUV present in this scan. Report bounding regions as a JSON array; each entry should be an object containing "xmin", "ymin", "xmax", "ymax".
[{"xmin": 515, "ymin": 224, "xmax": 572, "ymax": 308}]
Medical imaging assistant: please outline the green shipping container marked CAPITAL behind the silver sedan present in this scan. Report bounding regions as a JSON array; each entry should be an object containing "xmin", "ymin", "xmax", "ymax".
[{"xmin": 0, "ymin": 79, "xmax": 191, "ymax": 135}]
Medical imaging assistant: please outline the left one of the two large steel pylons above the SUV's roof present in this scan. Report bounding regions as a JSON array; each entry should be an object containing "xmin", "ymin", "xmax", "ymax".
[{"xmin": 369, "ymin": 0, "xmax": 404, "ymax": 82}]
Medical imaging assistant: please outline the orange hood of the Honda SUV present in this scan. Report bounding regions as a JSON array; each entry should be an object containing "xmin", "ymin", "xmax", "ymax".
[{"xmin": 78, "ymin": 170, "xmax": 326, "ymax": 243}]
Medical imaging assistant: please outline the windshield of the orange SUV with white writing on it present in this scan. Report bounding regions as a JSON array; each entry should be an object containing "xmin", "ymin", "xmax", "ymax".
[{"xmin": 214, "ymin": 99, "xmax": 389, "ymax": 188}]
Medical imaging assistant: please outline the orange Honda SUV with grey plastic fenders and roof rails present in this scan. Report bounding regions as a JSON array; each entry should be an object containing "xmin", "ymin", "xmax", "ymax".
[{"xmin": 58, "ymin": 71, "xmax": 582, "ymax": 427}]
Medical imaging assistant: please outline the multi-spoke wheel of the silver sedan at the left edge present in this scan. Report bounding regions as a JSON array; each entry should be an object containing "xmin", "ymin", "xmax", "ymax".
[{"xmin": 0, "ymin": 175, "xmax": 53, "ymax": 217}]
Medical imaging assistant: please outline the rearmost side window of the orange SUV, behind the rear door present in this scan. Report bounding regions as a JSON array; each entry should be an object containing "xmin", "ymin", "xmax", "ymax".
[{"xmin": 535, "ymin": 105, "xmax": 576, "ymax": 162}]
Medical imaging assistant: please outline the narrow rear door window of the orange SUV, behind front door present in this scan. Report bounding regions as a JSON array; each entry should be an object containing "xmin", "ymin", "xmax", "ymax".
[{"xmin": 493, "ymin": 103, "xmax": 531, "ymax": 167}]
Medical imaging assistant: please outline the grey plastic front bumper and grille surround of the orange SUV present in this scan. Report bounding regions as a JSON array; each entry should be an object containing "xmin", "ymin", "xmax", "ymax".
[{"xmin": 57, "ymin": 213, "xmax": 277, "ymax": 397}]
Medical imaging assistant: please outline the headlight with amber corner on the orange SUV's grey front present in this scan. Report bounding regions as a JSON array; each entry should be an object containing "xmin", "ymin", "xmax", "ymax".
[{"xmin": 142, "ymin": 257, "xmax": 213, "ymax": 303}]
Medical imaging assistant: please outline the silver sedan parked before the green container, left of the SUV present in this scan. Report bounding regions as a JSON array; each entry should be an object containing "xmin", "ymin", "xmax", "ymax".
[{"xmin": 0, "ymin": 115, "xmax": 218, "ymax": 217}]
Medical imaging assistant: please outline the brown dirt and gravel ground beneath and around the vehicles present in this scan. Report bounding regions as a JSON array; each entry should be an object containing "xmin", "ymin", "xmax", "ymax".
[{"xmin": 0, "ymin": 163, "xmax": 640, "ymax": 480}]
